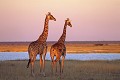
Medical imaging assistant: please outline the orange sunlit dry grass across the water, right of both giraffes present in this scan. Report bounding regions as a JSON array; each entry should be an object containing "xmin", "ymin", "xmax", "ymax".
[{"xmin": 67, "ymin": 44, "xmax": 120, "ymax": 53}]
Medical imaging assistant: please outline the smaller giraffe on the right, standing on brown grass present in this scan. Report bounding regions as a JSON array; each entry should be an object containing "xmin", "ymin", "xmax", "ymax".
[{"xmin": 50, "ymin": 18, "xmax": 72, "ymax": 75}]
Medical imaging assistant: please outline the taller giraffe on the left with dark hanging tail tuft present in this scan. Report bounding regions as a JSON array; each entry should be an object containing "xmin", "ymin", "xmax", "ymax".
[{"xmin": 27, "ymin": 12, "xmax": 56, "ymax": 76}]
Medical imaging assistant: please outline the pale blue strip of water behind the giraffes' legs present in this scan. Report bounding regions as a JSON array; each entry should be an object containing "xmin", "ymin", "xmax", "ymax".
[{"xmin": 0, "ymin": 52, "xmax": 120, "ymax": 61}]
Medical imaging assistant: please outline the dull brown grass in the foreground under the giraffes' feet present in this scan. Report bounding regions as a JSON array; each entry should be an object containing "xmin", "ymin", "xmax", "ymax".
[{"xmin": 0, "ymin": 60, "xmax": 120, "ymax": 80}]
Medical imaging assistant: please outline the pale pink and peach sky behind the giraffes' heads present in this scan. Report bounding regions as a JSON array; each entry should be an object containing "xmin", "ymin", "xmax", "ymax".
[{"xmin": 0, "ymin": 0, "xmax": 120, "ymax": 42}]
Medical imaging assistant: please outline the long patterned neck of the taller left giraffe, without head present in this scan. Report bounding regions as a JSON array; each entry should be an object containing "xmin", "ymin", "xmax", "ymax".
[{"xmin": 37, "ymin": 16, "xmax": 49, "ymax": 42}]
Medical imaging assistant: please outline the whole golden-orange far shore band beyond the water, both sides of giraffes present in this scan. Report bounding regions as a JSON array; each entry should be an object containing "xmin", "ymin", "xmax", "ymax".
[{"xmin": 0, "ymin": 41, "xmax": 120, "ymax": 53}]
